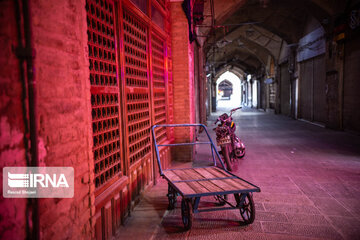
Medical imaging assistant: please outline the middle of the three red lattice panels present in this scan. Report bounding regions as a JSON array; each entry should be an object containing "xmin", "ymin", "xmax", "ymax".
[{"xmin": 123, "ymin": 9, "xmax": 151, "ymax": 167}]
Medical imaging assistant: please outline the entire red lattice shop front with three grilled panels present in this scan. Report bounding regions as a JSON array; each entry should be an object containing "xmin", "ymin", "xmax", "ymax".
[{"xmin": 86, "ymin": 0, "xmax": 173, "ymax": 239}]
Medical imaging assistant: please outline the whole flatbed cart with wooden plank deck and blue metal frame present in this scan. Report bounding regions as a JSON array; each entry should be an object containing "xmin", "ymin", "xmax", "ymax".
[{"xmin": 152, "ymin": 124, "xmax": 260, "ymax": 229}]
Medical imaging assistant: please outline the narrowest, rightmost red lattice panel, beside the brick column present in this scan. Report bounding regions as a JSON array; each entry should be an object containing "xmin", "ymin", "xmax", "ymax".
[{"xmin": 151, "ymin": 33, "xmax": 167, "ymax": 142}]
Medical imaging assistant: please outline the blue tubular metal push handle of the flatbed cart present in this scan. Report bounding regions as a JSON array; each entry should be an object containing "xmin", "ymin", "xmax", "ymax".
[{"xmin": 151, "ymin": 123, "xmax": 227, "ymax": 176}]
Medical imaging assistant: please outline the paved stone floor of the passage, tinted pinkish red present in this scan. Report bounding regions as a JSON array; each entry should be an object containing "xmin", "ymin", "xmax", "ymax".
[{"xmin": 117, "ymin": 109, "xmax": 360, "ymax": 239}]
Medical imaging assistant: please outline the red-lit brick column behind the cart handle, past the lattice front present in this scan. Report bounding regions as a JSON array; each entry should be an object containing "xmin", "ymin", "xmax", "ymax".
[{"xmin": 170, "ymin": 1, "xmax": 195, "ymax": 161}]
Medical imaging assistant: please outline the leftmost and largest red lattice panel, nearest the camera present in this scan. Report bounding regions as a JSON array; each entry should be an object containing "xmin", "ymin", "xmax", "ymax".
[{"xmin": 86, "ymin": 0, "xmax": 121, "ymax": 188}]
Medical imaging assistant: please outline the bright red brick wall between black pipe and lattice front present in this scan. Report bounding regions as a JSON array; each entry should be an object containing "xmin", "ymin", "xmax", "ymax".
[{"xmin": 32, "ymin": 0, "xmax": 94, "ymax": 239}]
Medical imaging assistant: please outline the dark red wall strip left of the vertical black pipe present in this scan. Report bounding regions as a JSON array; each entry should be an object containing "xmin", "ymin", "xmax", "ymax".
[{"xmin": 0, "ymin": 0, "xmax": 27, "ymax": 239}]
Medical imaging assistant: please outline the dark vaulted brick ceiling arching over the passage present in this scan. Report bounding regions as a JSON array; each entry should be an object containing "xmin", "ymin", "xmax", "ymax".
[{"xmin": 200, "ymin": 0, "xmax": 346, "ymax": 73}]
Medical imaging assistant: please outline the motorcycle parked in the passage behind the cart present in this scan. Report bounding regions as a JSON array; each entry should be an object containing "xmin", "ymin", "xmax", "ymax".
[{"xmin": 213, "ymin": 107, "xmax": 245, "ymax": 171}]
